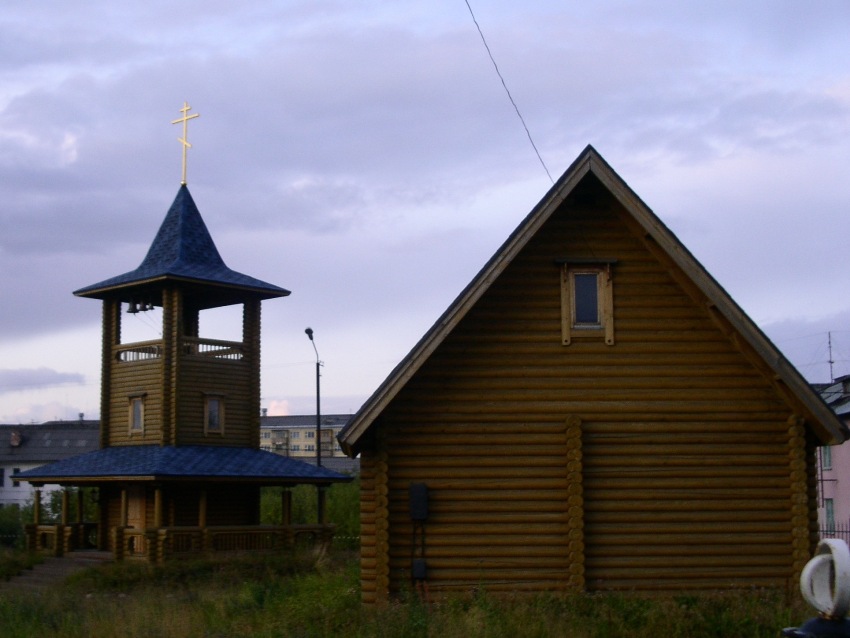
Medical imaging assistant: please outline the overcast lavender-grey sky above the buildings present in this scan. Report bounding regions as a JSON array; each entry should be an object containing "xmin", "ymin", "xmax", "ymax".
[{"xmin": 0, "ymin": 0, "xmax": 850, "ymax": 423}]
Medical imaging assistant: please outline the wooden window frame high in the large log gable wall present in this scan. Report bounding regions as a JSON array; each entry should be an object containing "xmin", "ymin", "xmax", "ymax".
[{"xmin": 557, "ymin": 259, "xmax": 616, "ymax": 346}]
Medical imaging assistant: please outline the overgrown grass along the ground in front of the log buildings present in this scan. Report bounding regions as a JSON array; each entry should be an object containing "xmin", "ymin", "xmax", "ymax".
[{"xmin": 0, "ymin": 551, "xmax": 812, "ymax": 638}]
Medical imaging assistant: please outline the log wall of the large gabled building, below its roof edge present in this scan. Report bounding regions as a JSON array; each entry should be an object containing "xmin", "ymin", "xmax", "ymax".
[{"xmin": 361, "ymin": 178, "xmax": 813, "ymax": 601}]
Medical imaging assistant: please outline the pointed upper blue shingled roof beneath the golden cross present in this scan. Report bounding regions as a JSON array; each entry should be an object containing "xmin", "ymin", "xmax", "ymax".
[{"xmin": 74, "ymin": 184, "xmax": 289, "ymax": 298}]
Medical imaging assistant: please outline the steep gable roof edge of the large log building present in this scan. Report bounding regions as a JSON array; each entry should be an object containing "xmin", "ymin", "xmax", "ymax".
[{"xmin": 338, "ymin": 145, "xmax": 848, "ymax": 454}]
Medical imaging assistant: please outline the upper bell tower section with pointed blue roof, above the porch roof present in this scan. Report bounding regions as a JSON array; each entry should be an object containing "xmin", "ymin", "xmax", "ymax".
[{"xmin": 74, "ymin": 184, "xmax": 289, "ymax": 449}]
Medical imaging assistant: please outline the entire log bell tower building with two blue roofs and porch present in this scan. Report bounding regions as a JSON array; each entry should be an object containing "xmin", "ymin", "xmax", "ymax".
[{"xmin": 16, "ymin": 183, "xmax": 350, "ymax": 561}]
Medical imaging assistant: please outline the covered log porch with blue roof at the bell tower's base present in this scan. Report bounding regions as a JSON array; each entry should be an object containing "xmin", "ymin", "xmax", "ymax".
[{"xmin": 21, "ymin": 446, "xmax": 351, "ymax": 562}]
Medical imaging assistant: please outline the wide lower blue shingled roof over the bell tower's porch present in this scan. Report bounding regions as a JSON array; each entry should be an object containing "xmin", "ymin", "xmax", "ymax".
[{"xmin": 16, "ymin": 445, "xmax": 350, "ymax": 483}]
